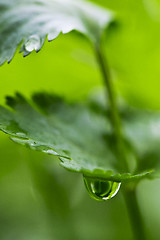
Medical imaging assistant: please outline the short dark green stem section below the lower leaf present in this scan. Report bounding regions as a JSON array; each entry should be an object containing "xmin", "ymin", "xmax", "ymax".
[{"xmin": 123, "ymin": 188, "xmax": 146, "ymax": 240}]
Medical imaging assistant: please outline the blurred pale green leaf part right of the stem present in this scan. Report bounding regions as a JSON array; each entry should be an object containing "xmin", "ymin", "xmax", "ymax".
[{"xmin": 123, "ymin": 107, "xmax": 160, "ymax": 174}]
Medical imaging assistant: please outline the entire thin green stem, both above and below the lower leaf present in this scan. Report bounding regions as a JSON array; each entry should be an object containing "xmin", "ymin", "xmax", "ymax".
[{"xmin": 95, "ymin": 43, "xmax": 146, "ymax": 240}]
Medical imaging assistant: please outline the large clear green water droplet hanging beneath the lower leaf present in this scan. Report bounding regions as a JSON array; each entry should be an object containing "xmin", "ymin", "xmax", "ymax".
[{"xmin": 83, "ymin": 176, "xmax": 121, "ymax": 201}]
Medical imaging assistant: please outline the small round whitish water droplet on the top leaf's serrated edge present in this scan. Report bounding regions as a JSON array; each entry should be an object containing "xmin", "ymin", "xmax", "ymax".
[{"xmin": 25, "ymin": 35, "xmax": 41, "ymax": 52}]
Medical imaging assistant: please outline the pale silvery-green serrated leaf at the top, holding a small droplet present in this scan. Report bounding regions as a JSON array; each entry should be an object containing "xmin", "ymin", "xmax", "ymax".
[{"xmin": 0, "ymin": 0, "xmax": 113, "ymax": 64}]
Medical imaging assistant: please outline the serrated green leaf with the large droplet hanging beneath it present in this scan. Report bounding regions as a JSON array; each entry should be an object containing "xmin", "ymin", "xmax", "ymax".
[{"xmin": 0, "ymin": 93, "xmax": 150, "ymax": 181}]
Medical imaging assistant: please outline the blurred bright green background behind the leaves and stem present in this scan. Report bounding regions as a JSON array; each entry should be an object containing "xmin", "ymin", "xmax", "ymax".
[{"xmin": 0, "ymin": 0, "xmax": 160, "ymax": 240}]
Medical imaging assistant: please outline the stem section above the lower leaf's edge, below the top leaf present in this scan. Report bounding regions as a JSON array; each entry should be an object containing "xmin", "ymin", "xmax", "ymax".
[{"xmin": 95, "ymin": 43, "xmax": 128, "ymax": 171}]
